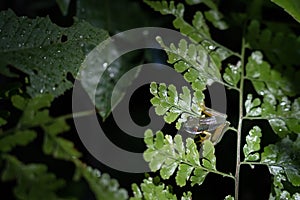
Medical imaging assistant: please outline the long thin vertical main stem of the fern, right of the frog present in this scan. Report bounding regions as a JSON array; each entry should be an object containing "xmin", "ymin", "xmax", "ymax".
[{"xmin": 234, "ymin": 38, "xmax": 245, "ymax": 200}]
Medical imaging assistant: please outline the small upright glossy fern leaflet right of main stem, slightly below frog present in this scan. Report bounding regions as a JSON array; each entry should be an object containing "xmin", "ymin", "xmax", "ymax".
[{"xmin": 243, "ymin": 126, "xmax": 262, "ymax": 161}]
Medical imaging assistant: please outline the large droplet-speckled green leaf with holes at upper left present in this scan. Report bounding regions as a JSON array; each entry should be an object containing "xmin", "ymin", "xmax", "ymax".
[{"xmin": 0, "ymin": 10, "xmax": 108, "ymax": 97}]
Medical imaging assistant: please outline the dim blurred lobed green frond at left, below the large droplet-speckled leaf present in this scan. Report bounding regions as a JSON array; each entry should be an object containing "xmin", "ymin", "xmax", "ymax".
[{"xmin": 9, "ymin": 94, "xmax": 81, "ymax": 161}]
